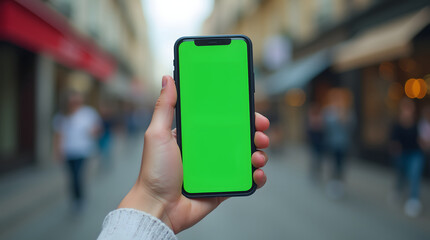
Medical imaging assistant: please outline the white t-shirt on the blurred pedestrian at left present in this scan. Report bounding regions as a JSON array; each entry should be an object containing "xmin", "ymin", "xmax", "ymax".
[{"xmin": 54, "ymin": 106, "xmax": 101, "ymax": 160}]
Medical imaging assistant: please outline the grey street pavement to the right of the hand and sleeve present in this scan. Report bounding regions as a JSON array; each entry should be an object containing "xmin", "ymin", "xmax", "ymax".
[{"xmin": 179, "ymin": 145, "xmax": 430, "ymax": 240}]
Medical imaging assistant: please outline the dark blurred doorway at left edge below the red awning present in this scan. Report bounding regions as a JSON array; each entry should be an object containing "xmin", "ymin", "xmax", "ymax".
[{"xmin": 0, "ymin": 43, "xmax": 36, "ymax": 174}]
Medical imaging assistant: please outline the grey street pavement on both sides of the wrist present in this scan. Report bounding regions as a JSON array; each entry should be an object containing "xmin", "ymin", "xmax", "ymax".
[{"xmin": 0, "ymin": 138, "xmax": 430, "ymax": 240}]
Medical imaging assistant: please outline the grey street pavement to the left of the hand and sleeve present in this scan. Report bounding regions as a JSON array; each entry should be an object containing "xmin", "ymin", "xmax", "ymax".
[{"xmin": 0, "ymin": 133, "xmax": 143, "ymax": 240}]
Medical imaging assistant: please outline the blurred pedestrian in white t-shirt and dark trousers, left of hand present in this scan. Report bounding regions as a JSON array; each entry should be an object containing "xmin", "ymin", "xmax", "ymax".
[{"xmin": 53, "ymin": 91, "xmax": 101, "ymax": 210}]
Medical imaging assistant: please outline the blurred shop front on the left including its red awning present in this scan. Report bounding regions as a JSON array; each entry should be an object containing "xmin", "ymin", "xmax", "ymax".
[{"xmin": 0, "ymin": 0, "xmax": 116, "ymax": 174}]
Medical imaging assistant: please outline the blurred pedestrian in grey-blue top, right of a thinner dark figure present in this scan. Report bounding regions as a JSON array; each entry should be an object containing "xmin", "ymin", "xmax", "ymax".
[{"xmin": 324, "ymin": 88, "xmax": 355, "ymax": 199}]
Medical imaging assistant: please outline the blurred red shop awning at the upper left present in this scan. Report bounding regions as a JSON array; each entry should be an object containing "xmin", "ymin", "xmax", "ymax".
[{"xmin": 0, "ymin": 0, "xmax": 116, "ymax": 80}]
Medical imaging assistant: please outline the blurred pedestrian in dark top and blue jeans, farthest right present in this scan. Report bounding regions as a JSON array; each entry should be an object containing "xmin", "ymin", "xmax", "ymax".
[{"xmin": 391, "ymin": 98, "xmax": 424, "ymax": 217}]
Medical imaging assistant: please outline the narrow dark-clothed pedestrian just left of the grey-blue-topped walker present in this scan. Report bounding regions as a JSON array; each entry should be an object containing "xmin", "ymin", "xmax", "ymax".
[{"xmin": 307, "ymin": 103, "xmax": 324, "ymax": 182}]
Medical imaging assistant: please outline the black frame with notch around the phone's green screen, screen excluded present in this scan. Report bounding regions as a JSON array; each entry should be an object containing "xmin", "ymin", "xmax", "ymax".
[{"xmin": 173, "ymin": 34, "xmax": 257, "ymax": 198}]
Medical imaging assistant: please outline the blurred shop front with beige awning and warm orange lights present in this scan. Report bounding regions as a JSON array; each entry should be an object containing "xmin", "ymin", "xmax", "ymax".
[{"xmin": 334, "ymin": 8, "xmax": 430, "ymax": 164}]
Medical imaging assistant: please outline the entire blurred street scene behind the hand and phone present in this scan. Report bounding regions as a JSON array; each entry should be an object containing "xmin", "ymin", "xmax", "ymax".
[{"xmin": 0, "ymin": 0, "xmax": 430, "ymax": 240}]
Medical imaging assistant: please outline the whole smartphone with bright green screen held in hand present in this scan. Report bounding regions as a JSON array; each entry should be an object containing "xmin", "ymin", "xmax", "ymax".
[{"xmin": 174, "ymin": 35, "xmax": 256, "ymax": 198}]
